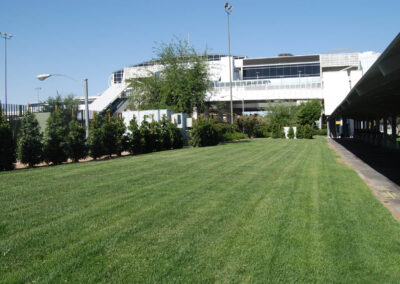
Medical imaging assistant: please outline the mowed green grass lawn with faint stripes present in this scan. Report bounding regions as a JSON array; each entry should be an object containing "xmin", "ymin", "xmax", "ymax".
[{"xmin": 0, "ymin": 138, "xmax": 400, "ymax": 283}]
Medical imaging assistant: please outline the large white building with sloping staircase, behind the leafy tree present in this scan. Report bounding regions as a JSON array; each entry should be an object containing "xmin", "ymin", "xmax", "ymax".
[{"xmin": 90, "ymin": 52, "xmax": 380, "ymax": 120}]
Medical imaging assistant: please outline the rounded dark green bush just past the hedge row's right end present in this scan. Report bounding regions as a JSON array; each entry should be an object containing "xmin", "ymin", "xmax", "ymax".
[{"xmin": 190, "ymin": 118, "xmax": 220, "ymax": 147}]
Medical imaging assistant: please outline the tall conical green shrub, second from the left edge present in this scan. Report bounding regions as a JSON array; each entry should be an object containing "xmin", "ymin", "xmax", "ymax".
[{"xmin": 17, "ymin": 111, "xmax": 43, "ymax": 167}]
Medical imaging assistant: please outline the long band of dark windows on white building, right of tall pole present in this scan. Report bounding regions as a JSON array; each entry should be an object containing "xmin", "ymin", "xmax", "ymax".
[{"xmin": 243, "ymin": 63, "xmax": 320, "ymax": 80}]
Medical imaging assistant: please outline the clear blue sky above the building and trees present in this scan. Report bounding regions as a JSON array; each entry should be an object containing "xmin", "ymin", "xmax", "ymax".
[{"xmin": 0, "ymin": 0, "xmax": 400, "ymax": 104}]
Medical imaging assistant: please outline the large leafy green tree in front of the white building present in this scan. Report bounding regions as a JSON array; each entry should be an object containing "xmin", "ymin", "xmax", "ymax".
[{"xmin": 128, "ymin": 39, "xmax": 210, "ymax": 113}]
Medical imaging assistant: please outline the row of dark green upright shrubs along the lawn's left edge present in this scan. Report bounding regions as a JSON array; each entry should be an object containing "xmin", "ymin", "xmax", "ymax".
[{"xmin": 0, "ymin": 110, "xmax": 184, "ymax": 170}]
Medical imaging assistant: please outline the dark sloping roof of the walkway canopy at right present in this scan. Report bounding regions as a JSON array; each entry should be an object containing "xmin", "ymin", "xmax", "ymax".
[{"xmin": 331, "ymin": 33, "xmax": 400, "ymax": 120}]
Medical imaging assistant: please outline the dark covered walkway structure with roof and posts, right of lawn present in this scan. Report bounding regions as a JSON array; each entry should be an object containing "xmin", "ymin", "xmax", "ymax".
[{"xmin": 328, "ymin": 33, "xmax": 400, "ymax": 150}]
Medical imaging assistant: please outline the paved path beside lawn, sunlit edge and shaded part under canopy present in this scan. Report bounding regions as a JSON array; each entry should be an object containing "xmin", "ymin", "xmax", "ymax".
[{"xmin": 327, "ymin": 138, "xmax": 400, "ymax": 222}]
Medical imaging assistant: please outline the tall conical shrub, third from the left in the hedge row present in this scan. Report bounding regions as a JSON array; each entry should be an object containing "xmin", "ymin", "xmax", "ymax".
[{"xmin": 43, "ymin": 110, "xmax": 68, "ymax": 165}]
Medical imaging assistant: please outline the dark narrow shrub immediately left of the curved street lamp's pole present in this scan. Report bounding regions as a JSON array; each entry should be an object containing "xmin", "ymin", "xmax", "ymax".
[{"xmin": 66, "ymin": 116, "xmax": 88, "ymax": 162}]
